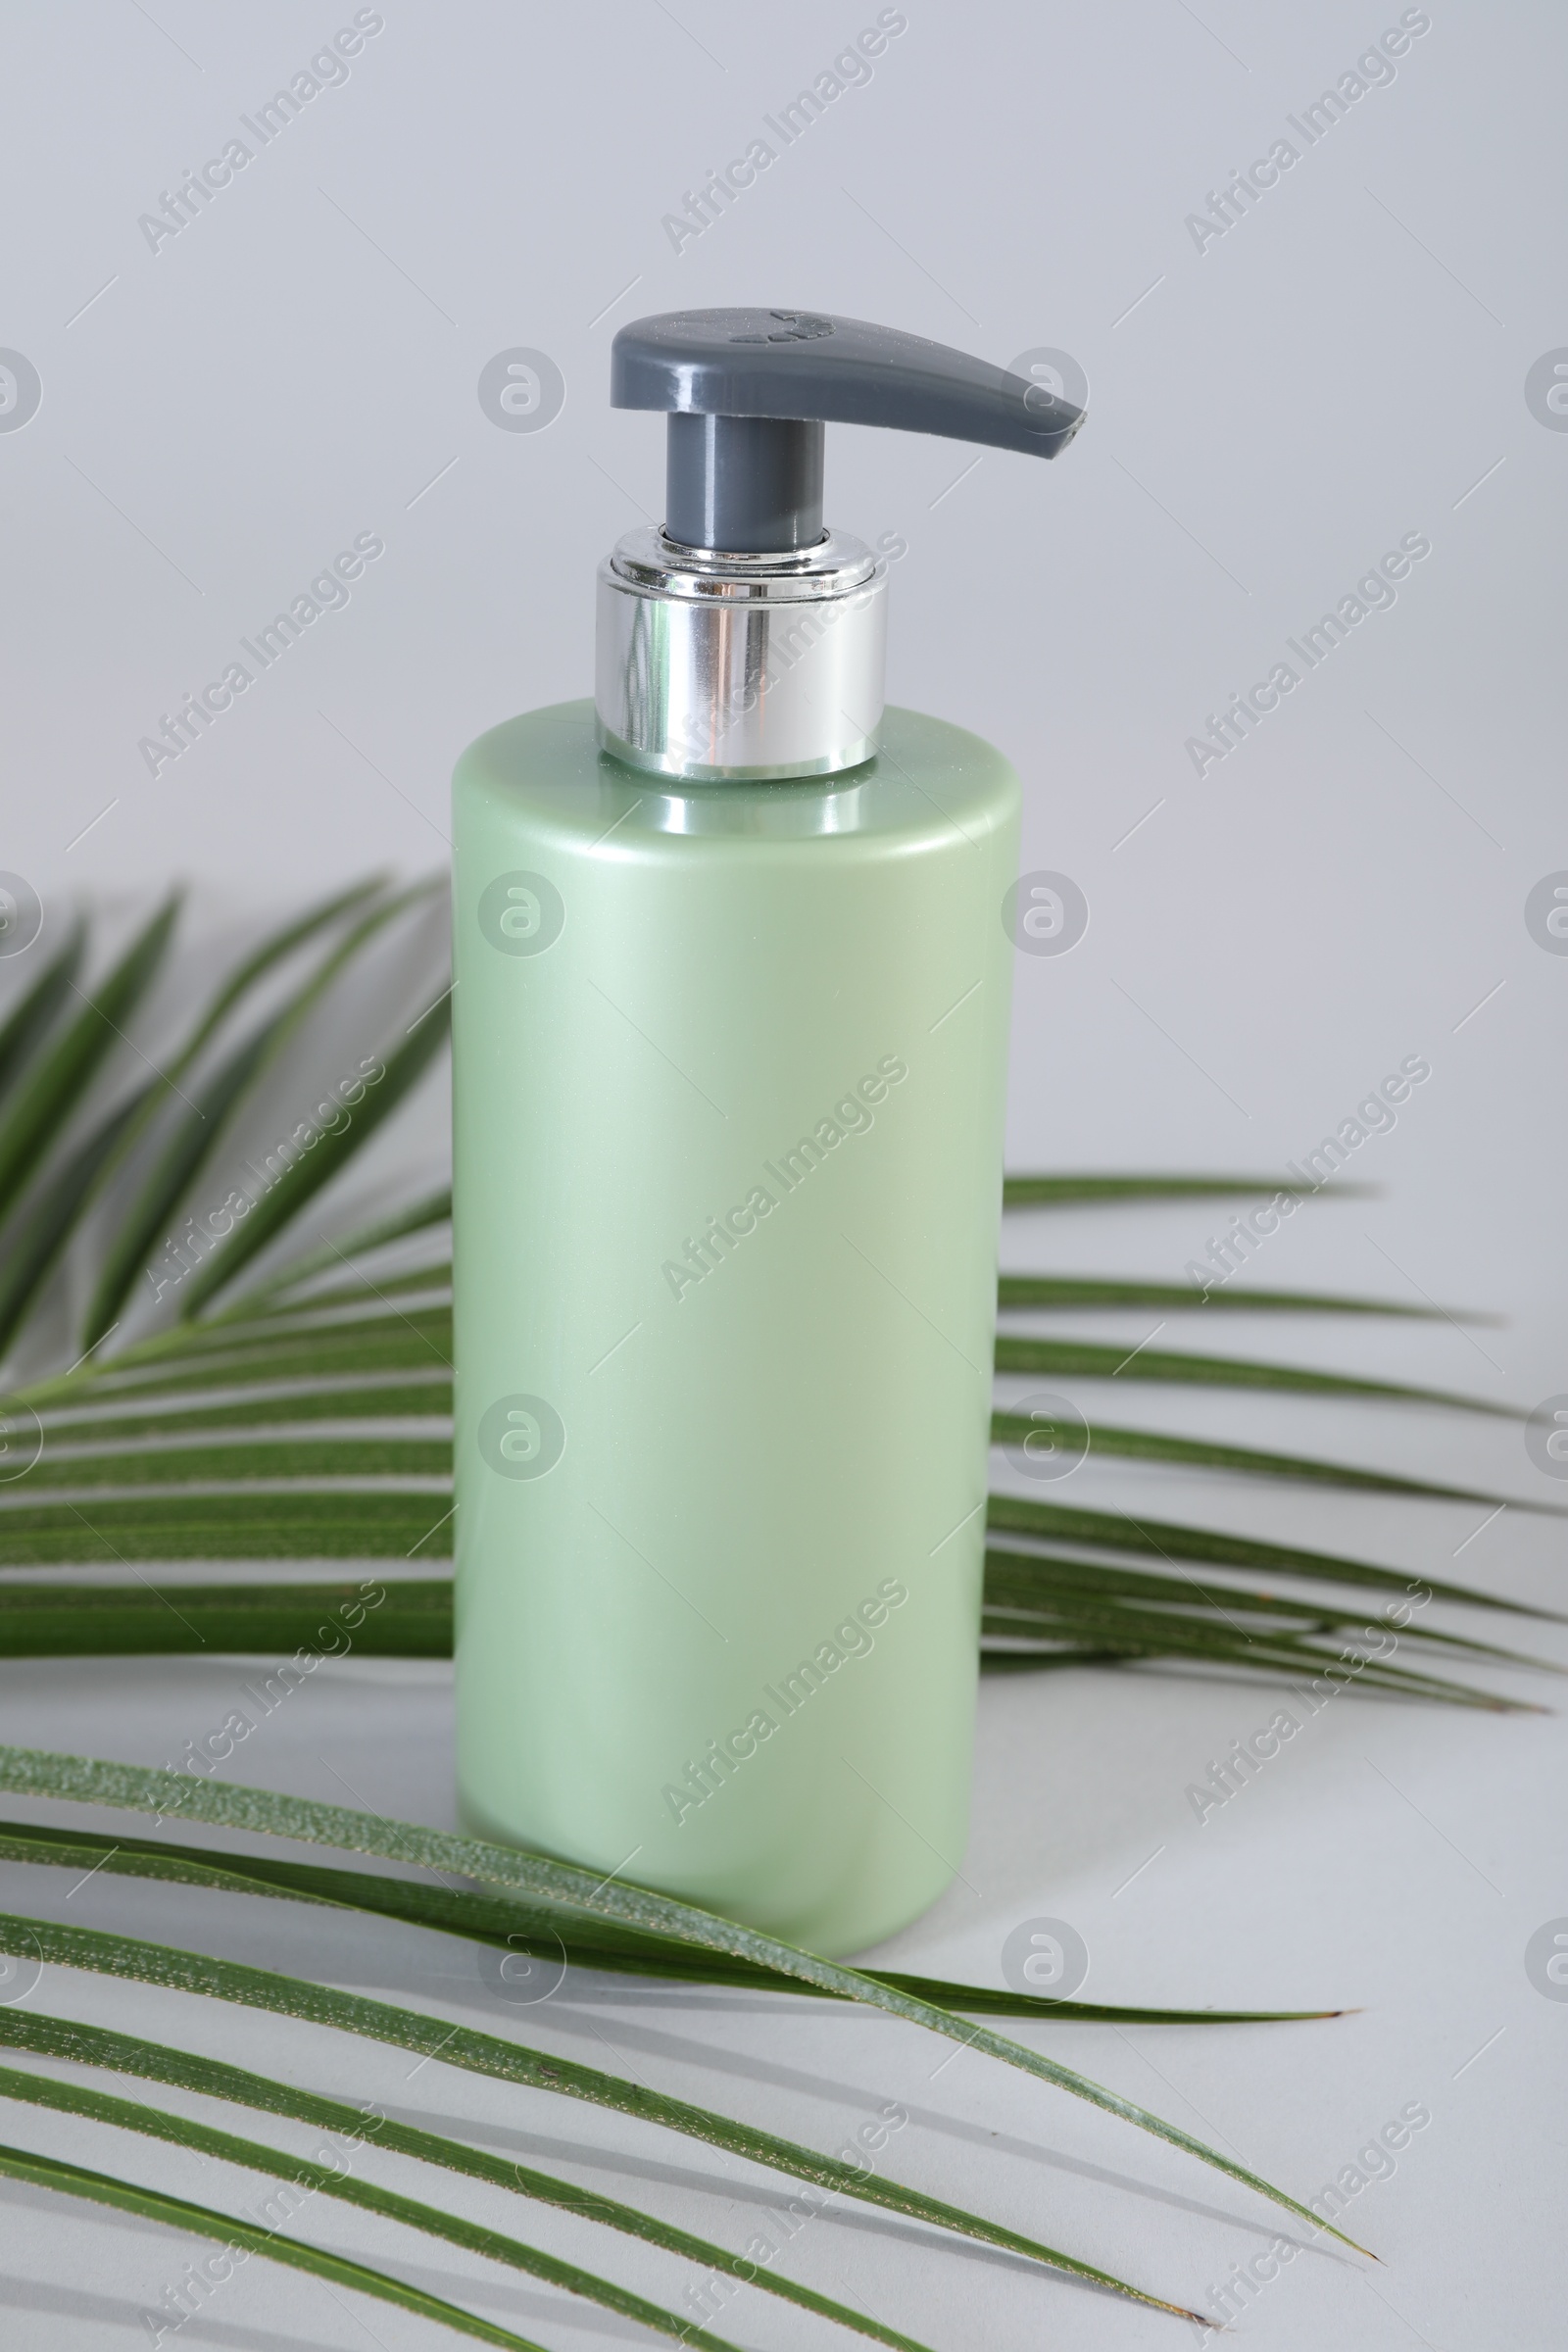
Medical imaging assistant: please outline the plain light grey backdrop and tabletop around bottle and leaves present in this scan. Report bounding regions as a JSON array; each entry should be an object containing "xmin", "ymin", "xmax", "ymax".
[{"xmin": 0, "ymin": 0, "xmax": 1568, "ymax": 2352}]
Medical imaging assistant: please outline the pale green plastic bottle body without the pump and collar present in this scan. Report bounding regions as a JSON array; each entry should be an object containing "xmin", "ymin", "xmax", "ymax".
[{"xmin": 454, "ymin": 704, "xmax": 1018, "ymax": 1952}]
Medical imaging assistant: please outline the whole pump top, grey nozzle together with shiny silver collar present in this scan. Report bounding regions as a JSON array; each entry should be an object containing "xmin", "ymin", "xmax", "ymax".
[{"xmin": 597, "ymin": 311, "xmax": 1084, "ymax": 781}]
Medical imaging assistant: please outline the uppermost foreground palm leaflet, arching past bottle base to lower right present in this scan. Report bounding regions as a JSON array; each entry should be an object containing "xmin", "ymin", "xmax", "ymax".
[{"xmin": 0, "ymin": 1747, "xmax": 1363, "ymax": 2251}]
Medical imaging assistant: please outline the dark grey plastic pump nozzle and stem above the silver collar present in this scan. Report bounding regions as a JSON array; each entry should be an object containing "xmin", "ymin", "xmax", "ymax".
[{"xmin": 609, "ymin": 311, "xmax": 1084, "ymax": 555}]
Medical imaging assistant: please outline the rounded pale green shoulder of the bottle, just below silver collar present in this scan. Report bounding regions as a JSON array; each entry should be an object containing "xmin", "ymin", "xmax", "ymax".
[{"xmin": 452, "ymin": 699, "xmax": 1020, "ymax": 854}]
